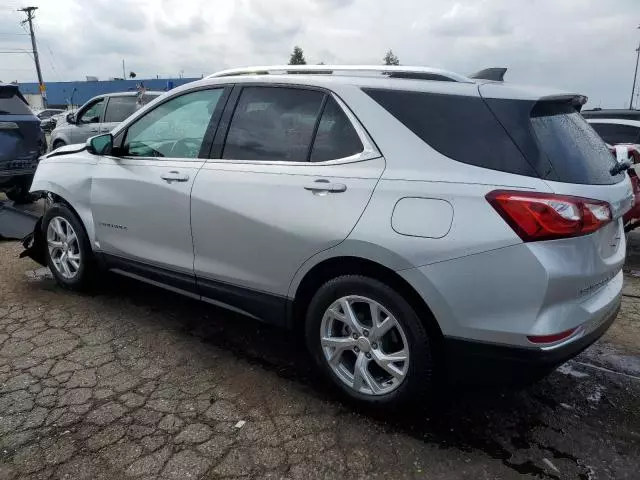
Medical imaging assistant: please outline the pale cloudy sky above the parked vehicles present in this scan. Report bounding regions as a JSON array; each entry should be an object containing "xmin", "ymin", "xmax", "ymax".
[{"xmin": 0, "ymin": 0, "xmax": 640, "ymax": 108}]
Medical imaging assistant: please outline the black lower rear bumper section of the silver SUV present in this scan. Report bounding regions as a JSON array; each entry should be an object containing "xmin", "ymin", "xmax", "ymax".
[{"xmin": 444, "ymin": 301, "xmax": 620, "ymax": 384}]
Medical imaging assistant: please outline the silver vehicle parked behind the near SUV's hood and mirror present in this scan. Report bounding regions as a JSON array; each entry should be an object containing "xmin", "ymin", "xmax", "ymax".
[{"xmin": 50, "ymin": 91, "xmax": 163, "ymax": 150}]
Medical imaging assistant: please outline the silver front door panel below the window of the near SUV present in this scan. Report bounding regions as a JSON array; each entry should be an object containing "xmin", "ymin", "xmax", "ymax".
[{"xmin": 91, "ymin": 157, "xmax": 203, "ymax": 273}]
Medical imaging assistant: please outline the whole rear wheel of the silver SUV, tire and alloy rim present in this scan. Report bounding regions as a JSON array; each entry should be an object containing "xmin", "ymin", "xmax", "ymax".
[{"xmin": 306, "ymin": 275, "xmax": 433, "ymax": 406}]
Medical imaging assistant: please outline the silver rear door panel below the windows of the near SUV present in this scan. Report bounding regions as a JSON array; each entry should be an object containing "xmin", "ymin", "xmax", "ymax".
[{"xmin": 191, "ymin": 157, "xmax": 385, "ymax": 295}]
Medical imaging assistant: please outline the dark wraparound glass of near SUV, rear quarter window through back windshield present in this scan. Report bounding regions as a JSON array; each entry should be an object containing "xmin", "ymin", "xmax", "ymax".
[{"xmin": 364, "ymin": 89, "xmax": 624, "ymax": 184}]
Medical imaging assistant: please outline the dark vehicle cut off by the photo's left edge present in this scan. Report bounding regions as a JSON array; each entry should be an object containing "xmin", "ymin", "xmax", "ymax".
[{"xmin": 0, "ymin": 83, "xmax": 47, "ymax": 203}]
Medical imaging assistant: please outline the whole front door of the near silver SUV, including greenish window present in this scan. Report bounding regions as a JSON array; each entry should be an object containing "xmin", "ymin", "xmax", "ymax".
[{"xmin": 91, "ymin": 88, "xmax": 223, "ymax": 280}]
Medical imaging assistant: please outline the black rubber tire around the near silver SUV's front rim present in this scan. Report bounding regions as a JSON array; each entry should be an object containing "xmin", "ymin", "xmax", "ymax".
[{"xmin": 42, "ymin": 203, "xmax": 97, "ymax": 291}]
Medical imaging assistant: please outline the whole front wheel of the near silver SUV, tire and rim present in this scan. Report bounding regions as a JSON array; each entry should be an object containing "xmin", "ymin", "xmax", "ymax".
[{"xmin": 42, "ymin": 204, "xmax": 96, "ymax": 290}]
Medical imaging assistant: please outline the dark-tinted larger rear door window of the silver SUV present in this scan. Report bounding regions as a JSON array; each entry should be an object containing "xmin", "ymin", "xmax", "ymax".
[{"xmin": 222, "ymin": 87, "xmax": 324, "ymax": 162}]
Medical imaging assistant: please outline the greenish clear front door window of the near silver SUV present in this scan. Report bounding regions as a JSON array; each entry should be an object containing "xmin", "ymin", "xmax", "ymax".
[{"xmin": 123, "ymin": 88, "xmax": 223, "ymax": 158}]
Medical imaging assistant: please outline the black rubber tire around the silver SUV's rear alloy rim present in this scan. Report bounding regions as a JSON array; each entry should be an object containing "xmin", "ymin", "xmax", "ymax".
[{"xmin": 305, "ymin": 275, "xmax": 434, "ymax": 407}]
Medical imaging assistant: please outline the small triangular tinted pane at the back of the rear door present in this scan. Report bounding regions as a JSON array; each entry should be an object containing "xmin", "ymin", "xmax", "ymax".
[{"xmin": 311, "ymin": 97, "xmax": 364, "ymax": 162}]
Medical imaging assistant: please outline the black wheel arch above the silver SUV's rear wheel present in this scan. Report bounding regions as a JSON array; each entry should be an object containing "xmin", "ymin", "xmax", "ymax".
[{"xmin": 291, "ymin": 256, "xmax": 443, "ymax": 344}]
